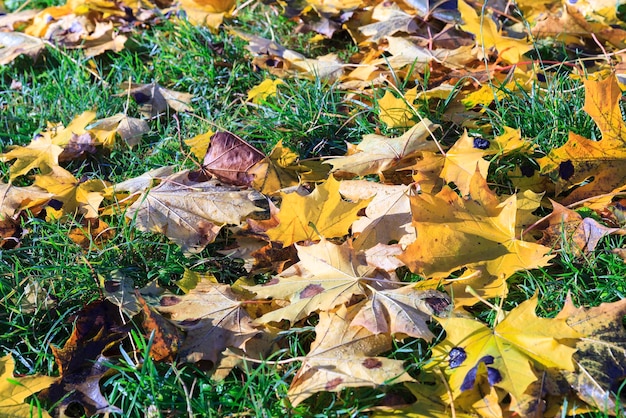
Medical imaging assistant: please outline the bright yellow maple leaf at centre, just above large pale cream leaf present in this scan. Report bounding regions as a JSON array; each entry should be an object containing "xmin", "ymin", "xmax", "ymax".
[{"xmin": 267, "ymin": 177, "xmax": 370, "ymax": 246}]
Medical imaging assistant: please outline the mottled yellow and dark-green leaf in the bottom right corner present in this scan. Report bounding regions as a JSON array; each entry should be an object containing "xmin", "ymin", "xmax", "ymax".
[{"xmin": 557, "ymin": 296, "xmax": 626, "ymax": 414}]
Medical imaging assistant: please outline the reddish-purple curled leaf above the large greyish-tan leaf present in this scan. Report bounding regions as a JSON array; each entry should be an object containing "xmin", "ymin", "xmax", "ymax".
[{"xmin": 202, "ymin": 132, "xmax": 265, "ymax": 186}]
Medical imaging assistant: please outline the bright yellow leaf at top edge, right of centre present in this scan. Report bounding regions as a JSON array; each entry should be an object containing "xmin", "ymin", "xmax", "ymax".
[{"xmin": 459, "ymin": 0, "xmax": 533, "ymax": 64}]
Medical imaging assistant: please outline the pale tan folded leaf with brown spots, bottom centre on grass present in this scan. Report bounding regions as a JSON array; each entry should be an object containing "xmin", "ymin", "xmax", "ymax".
[{"xmin": 287, "ymin": 305, "xmax": 413, "ymax": 406}]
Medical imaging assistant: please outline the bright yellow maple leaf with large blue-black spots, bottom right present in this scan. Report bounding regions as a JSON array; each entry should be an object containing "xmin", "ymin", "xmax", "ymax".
[{"xmin": 431, "ymin": 295, "xmax": 582, "ymax": 409}]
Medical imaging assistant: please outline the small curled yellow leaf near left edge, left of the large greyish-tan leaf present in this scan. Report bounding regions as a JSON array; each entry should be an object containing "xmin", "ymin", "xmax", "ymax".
[{"xmin": 34, "ymin": 167, "xmax": 107, "ymax": 218}]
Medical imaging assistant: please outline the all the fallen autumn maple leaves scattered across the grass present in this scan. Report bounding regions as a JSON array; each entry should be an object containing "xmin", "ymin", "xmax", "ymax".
[{"xmin": 0, "ymin": 0, "xmax": 626, "ymax": 416}]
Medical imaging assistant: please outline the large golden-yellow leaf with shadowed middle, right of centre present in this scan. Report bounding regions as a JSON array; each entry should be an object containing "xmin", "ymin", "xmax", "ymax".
[{"xmin": 399, "ymin": 172, "xmax": 554, "ymax": 278}]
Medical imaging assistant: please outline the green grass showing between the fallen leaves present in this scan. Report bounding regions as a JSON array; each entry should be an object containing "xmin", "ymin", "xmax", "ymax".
[{"xmin": 0, "ymin": 1, "xmax": 626, "ymax": 417}]
